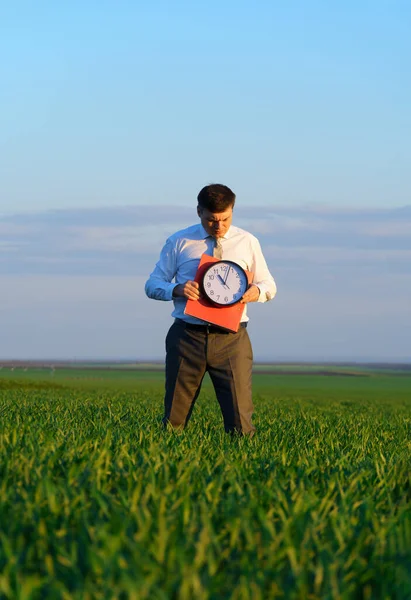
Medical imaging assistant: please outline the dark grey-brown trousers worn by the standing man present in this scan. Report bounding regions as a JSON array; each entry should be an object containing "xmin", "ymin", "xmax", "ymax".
[{"xmin": 163, "ymin": 319, "xmax": 255, "ymax": 435}]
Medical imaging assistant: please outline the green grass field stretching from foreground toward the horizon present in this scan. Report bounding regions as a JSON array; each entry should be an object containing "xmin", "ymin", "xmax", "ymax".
[{"xmin": 0, "ymin": 369, "xmax": 411, "ymax": 600}]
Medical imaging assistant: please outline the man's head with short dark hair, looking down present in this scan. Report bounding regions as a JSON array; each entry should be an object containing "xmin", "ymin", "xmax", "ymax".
[{"xmin": 197, "ymin": 183, "xmax": 235, "ymax": 237}]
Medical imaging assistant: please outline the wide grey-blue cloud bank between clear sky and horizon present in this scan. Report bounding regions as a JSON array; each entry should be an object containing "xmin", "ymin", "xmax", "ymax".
[{"xmin": 0, "ymin": 206, "xmax": 411, "ymax": 360}]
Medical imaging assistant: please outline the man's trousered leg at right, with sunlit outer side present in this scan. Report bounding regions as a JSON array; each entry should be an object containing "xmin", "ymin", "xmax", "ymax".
[{"xmin": 207, "ymin": 328, "xmax": 255, "ymax": 435}]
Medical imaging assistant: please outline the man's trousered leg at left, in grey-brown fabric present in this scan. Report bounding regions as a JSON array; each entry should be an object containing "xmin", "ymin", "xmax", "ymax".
[{"xmin": 163, "ymin": 321, "xmax": 207, "ymax": 429}]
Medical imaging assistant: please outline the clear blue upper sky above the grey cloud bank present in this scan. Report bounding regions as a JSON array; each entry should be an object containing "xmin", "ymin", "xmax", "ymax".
[{"xmin": 0, "ymin": 0, "xmax": 411, "ymax": 212}]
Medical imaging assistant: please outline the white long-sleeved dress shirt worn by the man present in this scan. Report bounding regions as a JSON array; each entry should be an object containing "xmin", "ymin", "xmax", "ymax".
[{"xmin": 145, "ymin": 223, "xmax": 277, "ymax": 324}]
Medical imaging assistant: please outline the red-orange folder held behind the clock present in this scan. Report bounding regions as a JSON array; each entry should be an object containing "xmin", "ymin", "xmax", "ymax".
[{"xmin": 184, "ymin": 254, "xmax": 253, "ymax": 332}]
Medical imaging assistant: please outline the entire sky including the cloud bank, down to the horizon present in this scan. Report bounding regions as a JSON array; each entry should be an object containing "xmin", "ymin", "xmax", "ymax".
[{"xmin": 0, "ymin": 0, "xmax": 411, "ymax": 360}]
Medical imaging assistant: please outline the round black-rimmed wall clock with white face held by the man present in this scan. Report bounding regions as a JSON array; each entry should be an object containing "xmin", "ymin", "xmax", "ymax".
[{"xmin": 202, "ymin": 260, "xmax": 248, "ymax": 306}]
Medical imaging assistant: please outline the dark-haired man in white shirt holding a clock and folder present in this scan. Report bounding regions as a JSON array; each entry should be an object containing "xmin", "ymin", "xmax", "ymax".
[{"xmin": 145, "ymin": 184, "xmax": 276, "ymax": 435}]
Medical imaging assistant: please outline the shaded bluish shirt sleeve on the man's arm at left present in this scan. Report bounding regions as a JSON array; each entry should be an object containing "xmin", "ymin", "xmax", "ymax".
[{"xmin": 145, "ymin": 239, "xmax": 177, "ymax": 300}]
